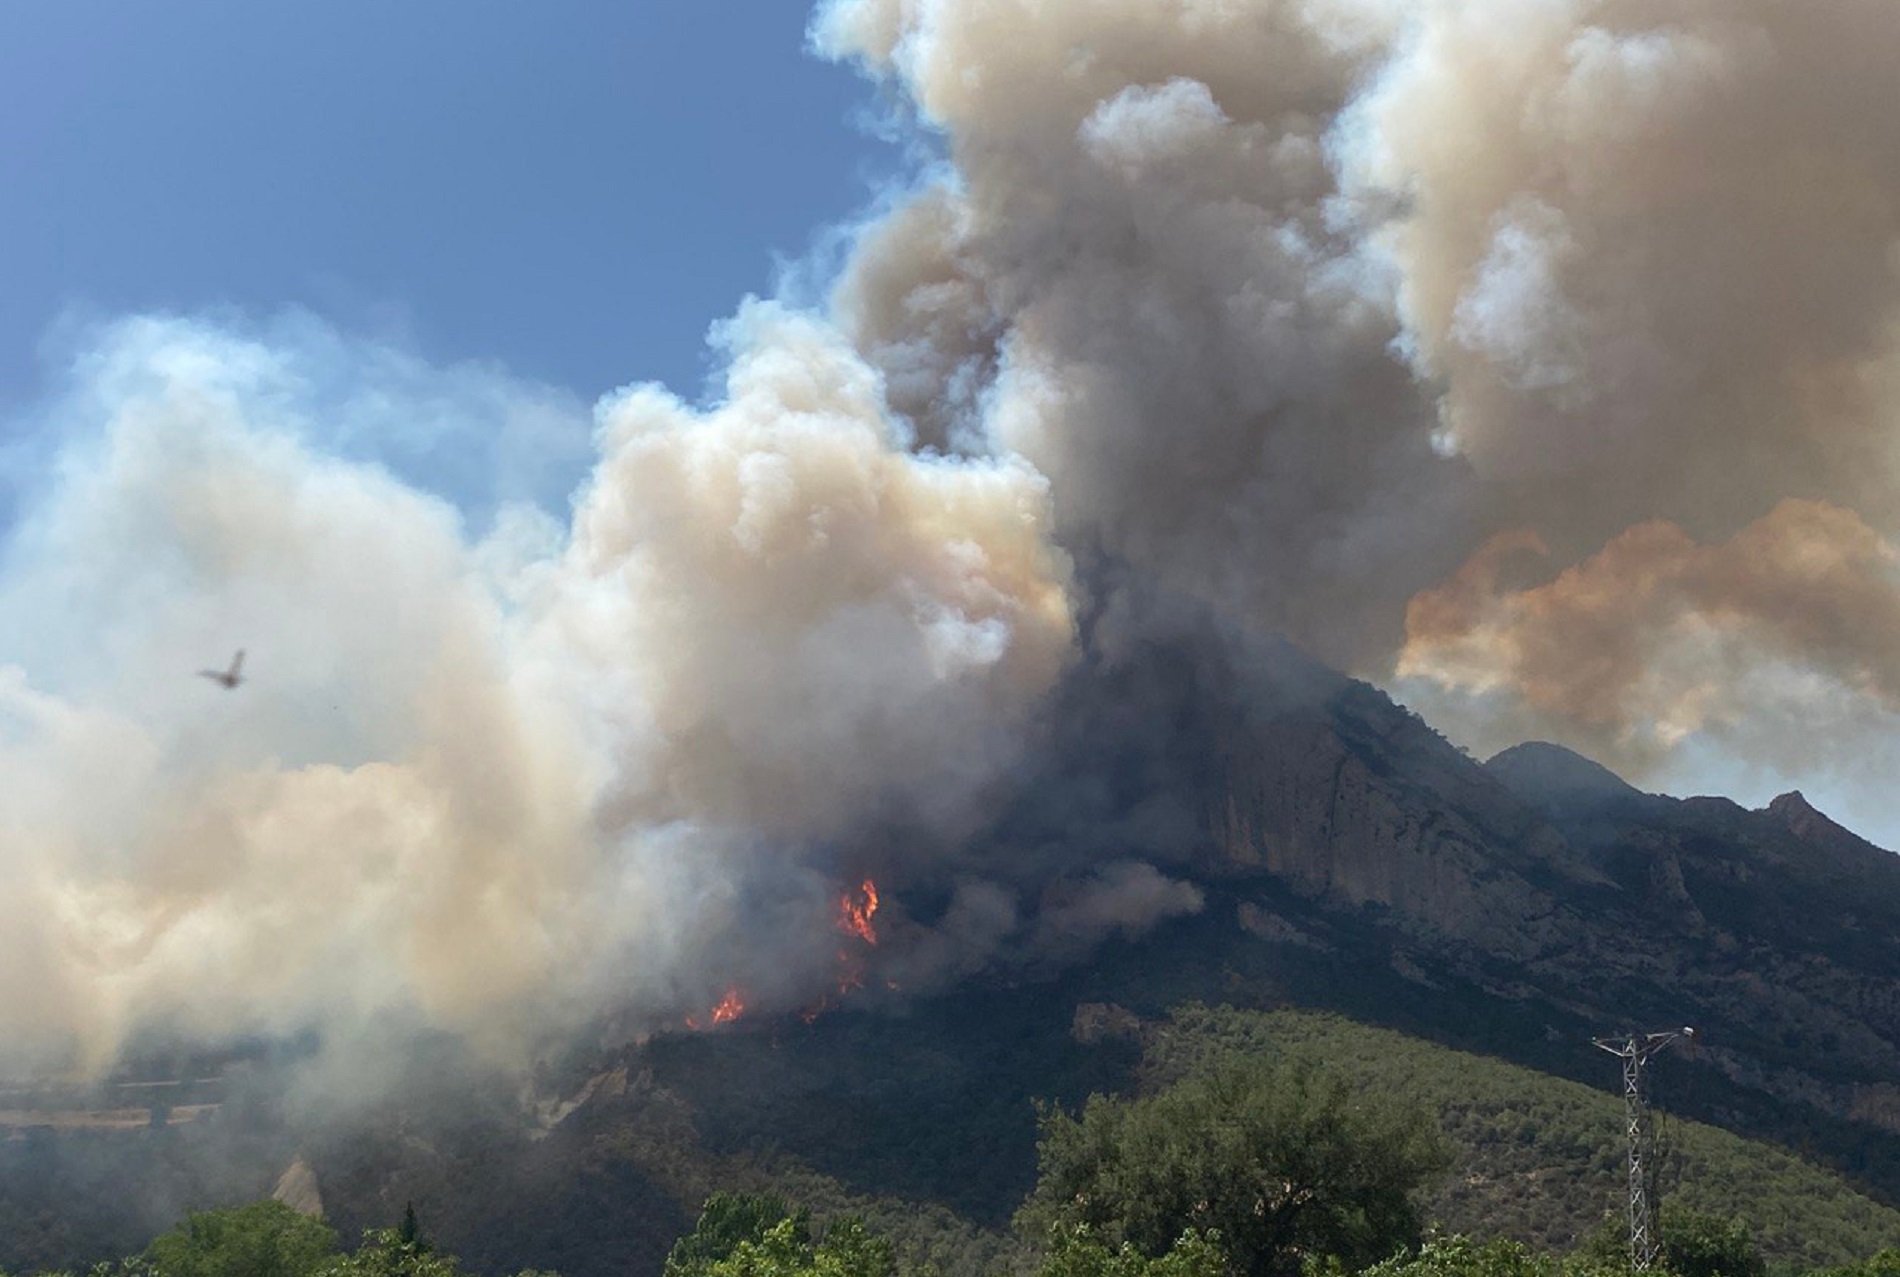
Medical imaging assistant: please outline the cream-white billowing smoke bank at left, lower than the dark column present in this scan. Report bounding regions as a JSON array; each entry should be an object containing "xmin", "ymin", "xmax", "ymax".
[{"xmin": 0, "ymin": 306, "xmax": 1072, "ymax": 1066}]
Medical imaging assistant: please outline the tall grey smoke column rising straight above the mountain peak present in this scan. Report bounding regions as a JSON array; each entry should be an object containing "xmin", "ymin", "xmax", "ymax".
[{"xmin": 817, "ymin": 4, "xmax": 1476, "ymax": 665}]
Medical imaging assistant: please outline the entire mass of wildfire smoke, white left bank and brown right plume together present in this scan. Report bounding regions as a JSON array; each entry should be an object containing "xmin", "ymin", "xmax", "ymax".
[{"xmin": 0, "ymin": 0, "xmax": 1900, "ymax": 1068}]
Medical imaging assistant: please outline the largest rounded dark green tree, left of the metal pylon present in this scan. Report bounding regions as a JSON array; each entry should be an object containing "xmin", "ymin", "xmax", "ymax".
[{"xmin": 1020, "ymin": 1062, "xmax": 1446, "ymax": 1277}]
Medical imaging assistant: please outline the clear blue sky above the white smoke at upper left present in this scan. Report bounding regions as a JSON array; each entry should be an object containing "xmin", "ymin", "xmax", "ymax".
[{"xmin": 0, "ymin": 0, "xmax": 899, "ymax": 407}]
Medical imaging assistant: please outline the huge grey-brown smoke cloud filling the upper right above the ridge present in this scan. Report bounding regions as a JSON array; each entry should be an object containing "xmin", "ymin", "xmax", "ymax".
[{"xmin": 817, "ymin": 0, "xmax": 1900, "ymax": 810}]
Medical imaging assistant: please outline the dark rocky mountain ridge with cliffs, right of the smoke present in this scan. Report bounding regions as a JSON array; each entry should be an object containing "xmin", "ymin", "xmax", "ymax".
[{"xmin": 1205, "ymin": 668, "xmax": 1900, "ymax": 1193}]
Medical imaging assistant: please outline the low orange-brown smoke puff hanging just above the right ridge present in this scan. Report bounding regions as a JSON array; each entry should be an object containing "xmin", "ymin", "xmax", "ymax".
[{"xmin": 1398, "ymin": 500, "xmax": 1900, "ymax": 766}]
